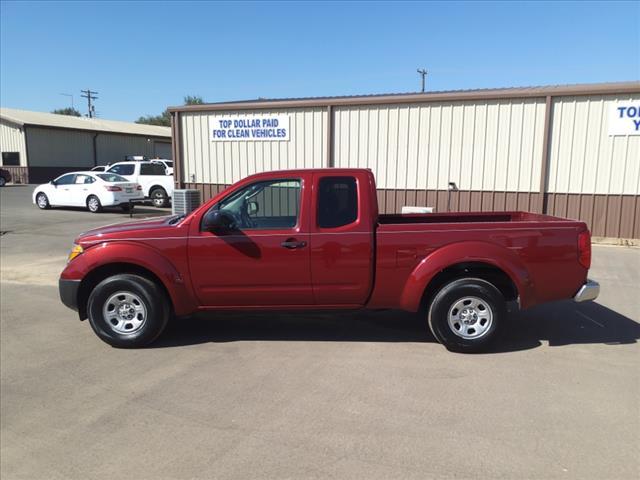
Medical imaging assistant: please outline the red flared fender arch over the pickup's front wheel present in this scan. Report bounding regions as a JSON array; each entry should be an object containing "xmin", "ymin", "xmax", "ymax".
[{"xmin": 61, "ymin": 241, "xmax": 197, "ymax": 315}]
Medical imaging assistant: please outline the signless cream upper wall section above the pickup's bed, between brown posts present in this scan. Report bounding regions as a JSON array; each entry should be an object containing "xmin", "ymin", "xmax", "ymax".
[{"xmin": 334, "ymin": 99, "xmax": 545, "ymax": 192}]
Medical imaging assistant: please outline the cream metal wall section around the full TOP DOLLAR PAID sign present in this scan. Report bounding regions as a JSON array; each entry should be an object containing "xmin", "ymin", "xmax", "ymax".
[{"xmin": 181, "ymin": 108, "xmax": 327, "ymax": 184}]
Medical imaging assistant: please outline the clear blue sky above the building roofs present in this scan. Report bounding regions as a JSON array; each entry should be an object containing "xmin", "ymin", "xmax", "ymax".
[{"xmin": 0, "ymin": 1, "xmax": 640, "ymax": 120}]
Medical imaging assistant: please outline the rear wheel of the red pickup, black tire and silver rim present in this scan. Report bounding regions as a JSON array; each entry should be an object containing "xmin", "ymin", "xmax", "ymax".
[{"xmin": 427, "ymin": 278, "xmax": 507, "ymax": 352}]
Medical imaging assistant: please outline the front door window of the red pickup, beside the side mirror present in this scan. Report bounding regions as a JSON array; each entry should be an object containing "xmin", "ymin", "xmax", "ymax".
[{"xmin": 214, "ymin": 179, "xmax": 301, "ymax": 230}]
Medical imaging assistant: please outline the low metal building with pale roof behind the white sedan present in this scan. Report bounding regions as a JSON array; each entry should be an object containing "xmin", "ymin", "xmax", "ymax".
[{"xmin": 0, "ymin": 108, "xmax": 172, "ymax": 183}]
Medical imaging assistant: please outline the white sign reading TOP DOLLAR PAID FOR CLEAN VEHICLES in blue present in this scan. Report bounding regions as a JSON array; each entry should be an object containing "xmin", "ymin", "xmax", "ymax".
[{"xmin": 209, "ymin": 115, "xmax": 290, "ymax": 142}]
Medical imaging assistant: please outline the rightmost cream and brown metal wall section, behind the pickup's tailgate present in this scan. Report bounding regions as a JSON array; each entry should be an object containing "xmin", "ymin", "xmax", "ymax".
[{"xmin": 547, "ymin": 95, "xmax": 640, "ymax": 238}]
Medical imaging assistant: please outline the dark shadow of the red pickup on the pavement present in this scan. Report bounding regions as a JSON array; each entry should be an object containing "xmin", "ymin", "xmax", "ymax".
[{"xmin": 156, "ymin": 301, "xmax": 640, "ymax": 353}]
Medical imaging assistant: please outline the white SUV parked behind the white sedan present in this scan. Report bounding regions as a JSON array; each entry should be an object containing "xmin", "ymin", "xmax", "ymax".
[{"xmin": 107, "ymin": 162, "xmax": 173, "ymax": 207}]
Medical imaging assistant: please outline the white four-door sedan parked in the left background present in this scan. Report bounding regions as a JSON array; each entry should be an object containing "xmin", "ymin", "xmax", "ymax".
[{"xmin": 33, "ymin": 172, "xmax": 144, "ymax": 213}]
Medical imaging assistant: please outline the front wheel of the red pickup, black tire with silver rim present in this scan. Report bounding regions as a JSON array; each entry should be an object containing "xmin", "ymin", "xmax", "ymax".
[{"xmin": 87, "ymin": 274, "xmax": 171, "ymax": 348}]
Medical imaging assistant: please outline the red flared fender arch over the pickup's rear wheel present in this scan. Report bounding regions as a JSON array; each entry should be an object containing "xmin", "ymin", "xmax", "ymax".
[{"xmin": 400, "ymin": 242, "xmax": 533, "ymax": 312}]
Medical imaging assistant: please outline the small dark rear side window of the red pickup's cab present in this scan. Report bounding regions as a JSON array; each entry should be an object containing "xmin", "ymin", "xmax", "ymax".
[{"xmin": 318, "ymin": 177, "xmax": 358, "ymax": 228}]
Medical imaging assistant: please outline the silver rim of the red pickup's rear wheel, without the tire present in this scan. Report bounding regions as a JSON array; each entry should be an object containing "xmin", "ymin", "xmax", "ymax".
[{"xmin": 447, "ymin": 297, "xmax": 493, "ymax": 340}]
